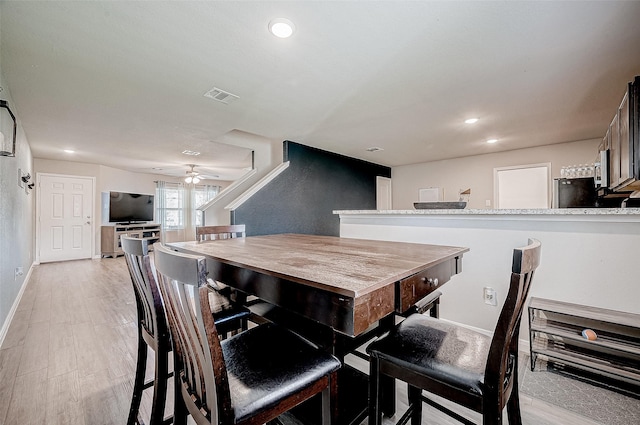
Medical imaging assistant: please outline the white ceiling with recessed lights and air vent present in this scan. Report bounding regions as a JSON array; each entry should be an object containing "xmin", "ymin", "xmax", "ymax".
[{"xmin": 0, "ymin": 1, "xmax": 640, "ymax": 179}]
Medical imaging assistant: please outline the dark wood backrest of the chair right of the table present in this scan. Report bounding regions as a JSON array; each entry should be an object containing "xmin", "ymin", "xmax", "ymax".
[{"xmin": 485, "ymin": 239, "xmax": 541, "ymax": 400}]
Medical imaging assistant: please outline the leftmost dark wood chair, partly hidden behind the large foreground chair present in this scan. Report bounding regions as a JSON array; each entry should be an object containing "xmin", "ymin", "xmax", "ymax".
[{"xmin": 120, "ymin": 236, "xmax": 173, "ymax": 425}]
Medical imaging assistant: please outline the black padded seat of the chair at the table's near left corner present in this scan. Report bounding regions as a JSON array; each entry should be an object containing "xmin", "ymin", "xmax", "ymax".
[{"xmin": 221, "ymin": 323, "xmax": 340, "ymax": 423}]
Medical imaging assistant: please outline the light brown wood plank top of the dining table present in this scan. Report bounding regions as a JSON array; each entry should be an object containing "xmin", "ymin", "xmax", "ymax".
[{"xmin": 169, "ymin": 234, "xmax": 469, "ymax": 298}]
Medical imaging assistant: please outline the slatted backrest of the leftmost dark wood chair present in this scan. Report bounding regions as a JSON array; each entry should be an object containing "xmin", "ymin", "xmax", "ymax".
[{"xmin": 120, "ymin": 236, "xmax": 169, "ymax": 350}]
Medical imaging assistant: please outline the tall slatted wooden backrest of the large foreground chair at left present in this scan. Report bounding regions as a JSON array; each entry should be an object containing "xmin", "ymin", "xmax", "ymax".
[{"xmin": 154, "ymin": 243, "xmax": 233, "ymax": 424}]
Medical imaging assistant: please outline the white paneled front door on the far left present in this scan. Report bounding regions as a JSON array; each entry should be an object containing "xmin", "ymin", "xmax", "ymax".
[{"xmin": 37, "ymin": 174, "xmax": 95, "ymax": 263}]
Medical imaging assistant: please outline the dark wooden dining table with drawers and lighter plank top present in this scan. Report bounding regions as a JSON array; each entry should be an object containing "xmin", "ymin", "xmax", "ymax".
[{"xmin": 167, "ymin": 234, "xmax": 469, "ymax": 425}]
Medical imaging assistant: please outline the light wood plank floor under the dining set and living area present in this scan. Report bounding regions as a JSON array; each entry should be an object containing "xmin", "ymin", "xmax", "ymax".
[{"xmin": 0, "ymin": 257, "xmax": 605, "ymax": 425}]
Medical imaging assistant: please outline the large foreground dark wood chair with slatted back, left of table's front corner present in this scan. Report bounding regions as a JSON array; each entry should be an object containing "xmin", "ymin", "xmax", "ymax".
[{"xmin": 154, "ymin": 244, "xmax": 340, "ymax": 425}]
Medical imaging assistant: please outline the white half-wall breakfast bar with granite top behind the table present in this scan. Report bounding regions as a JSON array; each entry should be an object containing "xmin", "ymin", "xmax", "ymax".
[{"xmin": 334, "ymin": 208, "xmax": 640, "ymax": 348}]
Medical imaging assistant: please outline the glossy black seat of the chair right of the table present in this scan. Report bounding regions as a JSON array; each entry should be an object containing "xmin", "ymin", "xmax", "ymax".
[{"xmin": 367, "ymin": 314, "xmax": 491, "ymax": 396}]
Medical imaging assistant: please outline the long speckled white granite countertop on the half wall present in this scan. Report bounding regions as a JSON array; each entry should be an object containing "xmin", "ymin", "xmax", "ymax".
[{"xmin": 333, "ymin": 208, "xmax": 640, "ymax": 216}]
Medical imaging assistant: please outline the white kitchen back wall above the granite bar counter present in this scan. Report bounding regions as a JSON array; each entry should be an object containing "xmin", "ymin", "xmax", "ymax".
[{"xmin": 391, "ymin": 139, "xmax": 600, "ymax": 210}]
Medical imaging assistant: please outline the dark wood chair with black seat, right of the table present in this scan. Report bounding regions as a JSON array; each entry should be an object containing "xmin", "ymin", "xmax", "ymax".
[{"xmin": 367, "ymin": 239, "xmax": 540, "ymax": 425}]
